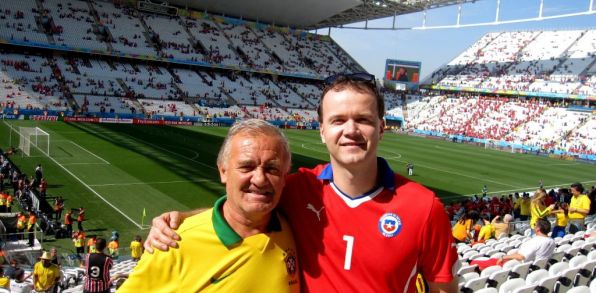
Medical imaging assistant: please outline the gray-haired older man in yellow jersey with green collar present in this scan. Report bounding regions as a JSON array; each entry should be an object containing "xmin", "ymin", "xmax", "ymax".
[{"xmin": 118, "ymin": 119, "xmax": 300, "ymax": 293}]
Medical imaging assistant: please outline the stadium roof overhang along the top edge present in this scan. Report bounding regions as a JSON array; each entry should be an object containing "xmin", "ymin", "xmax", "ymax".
[{"xmin": 169, "ymin": 0, "xmax": 476, "ymax": 29}]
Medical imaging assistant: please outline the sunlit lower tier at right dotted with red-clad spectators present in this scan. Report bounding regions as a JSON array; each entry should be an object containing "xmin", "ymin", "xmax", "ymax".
[{"xmin": 406, "ymin": 95, "xmax": 595, "ymax": 154}]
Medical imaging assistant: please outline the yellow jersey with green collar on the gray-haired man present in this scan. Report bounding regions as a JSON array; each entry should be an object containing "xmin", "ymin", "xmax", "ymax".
[{"xmin": 118, "ymin": 196, "xmax": 300, "ymax": 293}]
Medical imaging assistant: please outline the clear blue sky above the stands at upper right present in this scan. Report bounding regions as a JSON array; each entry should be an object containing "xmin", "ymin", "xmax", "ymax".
[{"xmin": 326, "ymin": 0, "xmax": 596, "ymax": 78}]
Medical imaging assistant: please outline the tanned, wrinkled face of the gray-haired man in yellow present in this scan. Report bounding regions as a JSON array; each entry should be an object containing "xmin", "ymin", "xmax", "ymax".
[{"xmin": 218, "ymin": 133, "xmax": 290, "ymax": 219}]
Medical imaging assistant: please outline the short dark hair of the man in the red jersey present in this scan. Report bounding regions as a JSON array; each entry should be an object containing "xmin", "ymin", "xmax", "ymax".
[{"xmin": 317, "ymin": 74, "xmax": 385, "ymax": 122}]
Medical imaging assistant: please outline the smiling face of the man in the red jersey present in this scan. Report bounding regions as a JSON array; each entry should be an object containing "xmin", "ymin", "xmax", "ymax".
[{"xmin": 320, "ymin": 87, "xmax": 384, "ymax": 168}]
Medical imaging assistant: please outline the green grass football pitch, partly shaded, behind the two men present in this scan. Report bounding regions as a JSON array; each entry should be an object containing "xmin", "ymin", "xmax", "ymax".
[{"xmin": 0, "ymin": 121, "xmax": 596, "ymax": 251}]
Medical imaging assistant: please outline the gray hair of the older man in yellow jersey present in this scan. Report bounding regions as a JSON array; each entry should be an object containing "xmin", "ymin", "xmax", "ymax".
[{"xmin": 217, "ymin": 119, "xmax": 292, "ymax": 172}]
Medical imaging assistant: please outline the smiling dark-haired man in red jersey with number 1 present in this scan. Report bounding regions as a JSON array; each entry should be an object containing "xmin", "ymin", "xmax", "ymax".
[{"xmin": 146, "ymin": 73, "xmax": 457, "ymax": 292}]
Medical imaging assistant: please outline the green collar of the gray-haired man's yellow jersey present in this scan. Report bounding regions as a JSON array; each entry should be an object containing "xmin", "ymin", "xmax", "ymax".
[{"xmin": 211, "ymin": 195, "xmax": 281, "ymax": 248}]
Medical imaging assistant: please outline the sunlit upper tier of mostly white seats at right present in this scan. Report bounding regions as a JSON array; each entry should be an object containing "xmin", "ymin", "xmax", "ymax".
[{"xmin": 429, "ymin": 30, "xmax": 596, "ymax": 94}]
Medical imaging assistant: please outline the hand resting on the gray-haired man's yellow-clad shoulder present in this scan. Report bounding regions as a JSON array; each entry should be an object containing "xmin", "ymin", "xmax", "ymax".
[{"xmin": 143, "ymin": 211, "xmax": 182, "ymax": 253}]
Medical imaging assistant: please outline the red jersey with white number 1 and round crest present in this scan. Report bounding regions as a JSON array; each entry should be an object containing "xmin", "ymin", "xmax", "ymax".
[{"xmin": 281, "ymin": 159, "xmax": 457, "ymax": 293}]
